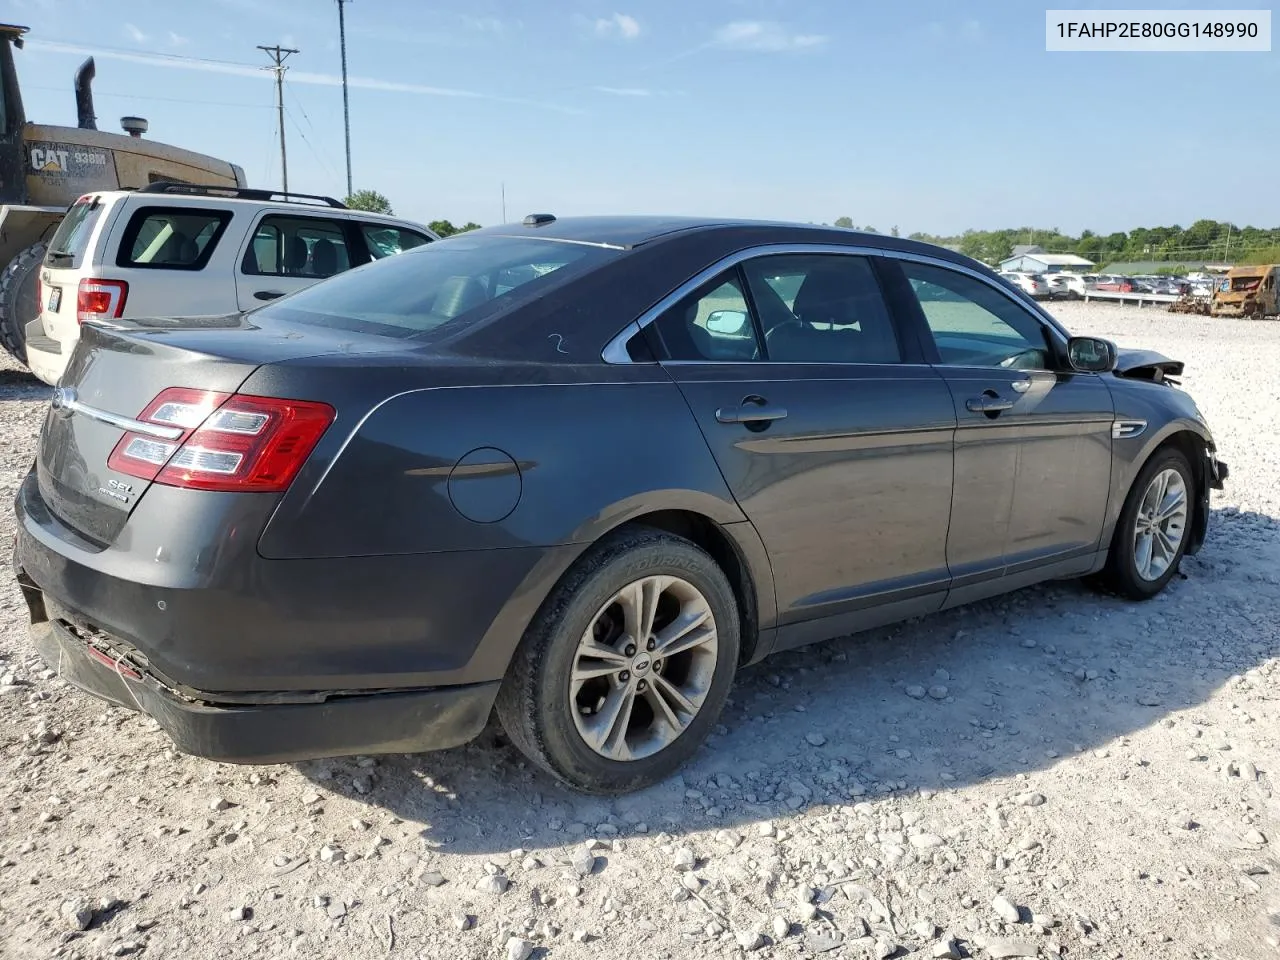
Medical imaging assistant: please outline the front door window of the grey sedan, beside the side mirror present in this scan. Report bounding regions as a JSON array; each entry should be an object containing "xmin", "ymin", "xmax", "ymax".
[{"xmin": 901, "ymin": 261, "xmax": 1052, "ymax": 370}]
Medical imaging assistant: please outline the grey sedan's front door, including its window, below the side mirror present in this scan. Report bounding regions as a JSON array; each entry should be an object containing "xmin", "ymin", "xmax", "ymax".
[{"xmin": 899, "ymin": 260, "xmax": 1114, "ymax": 603}]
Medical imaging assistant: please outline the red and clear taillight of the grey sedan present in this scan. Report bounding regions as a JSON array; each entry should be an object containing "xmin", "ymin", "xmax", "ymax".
[{"xmin": 106, "ymin": 387, "xmax": 334, "ymax": 493}]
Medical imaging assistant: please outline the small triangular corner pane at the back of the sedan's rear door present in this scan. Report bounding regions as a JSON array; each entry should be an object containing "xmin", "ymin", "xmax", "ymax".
[{"xmin": 654, "ymin": 270, "xmax": 760, "ymax": 362}]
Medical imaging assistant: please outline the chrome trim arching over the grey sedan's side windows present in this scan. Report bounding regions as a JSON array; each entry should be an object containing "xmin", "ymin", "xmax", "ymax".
[{"xmin": 600, "ymin": 243, "xmax": 1069, "ymax": 372}]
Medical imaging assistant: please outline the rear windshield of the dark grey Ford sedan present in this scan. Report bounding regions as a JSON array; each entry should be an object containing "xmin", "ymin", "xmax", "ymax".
[{"xmin": 256, "ymin": 236, "xmax": 618, "ymax": 338}]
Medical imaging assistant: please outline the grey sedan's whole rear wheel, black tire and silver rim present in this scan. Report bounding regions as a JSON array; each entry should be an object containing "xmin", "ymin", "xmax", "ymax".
[{"xmin": 497, "ymin": 529, "xmax": 741, "ymax": 794}]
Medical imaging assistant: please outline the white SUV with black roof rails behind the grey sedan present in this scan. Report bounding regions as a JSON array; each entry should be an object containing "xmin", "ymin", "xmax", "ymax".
[{"xmin": 27, "ymin": 183, "xmax": 439, "ymax": 384}]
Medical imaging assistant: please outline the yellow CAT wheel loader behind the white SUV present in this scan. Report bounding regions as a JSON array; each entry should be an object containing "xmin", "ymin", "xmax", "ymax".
[{"xmin": 0, "ymin": 24, "xmax": 248, "ymax": 362}]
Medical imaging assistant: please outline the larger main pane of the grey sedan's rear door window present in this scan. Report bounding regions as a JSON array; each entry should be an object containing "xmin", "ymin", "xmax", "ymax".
[{"xmin": 742, "ymin": 253, "xmax": 902, "ymax": 364}]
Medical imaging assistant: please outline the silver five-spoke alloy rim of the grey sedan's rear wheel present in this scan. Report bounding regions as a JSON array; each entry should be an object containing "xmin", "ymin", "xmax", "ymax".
[{"xmin": 568, "ymin": 576, "xmax": 719, "ymax": 762}]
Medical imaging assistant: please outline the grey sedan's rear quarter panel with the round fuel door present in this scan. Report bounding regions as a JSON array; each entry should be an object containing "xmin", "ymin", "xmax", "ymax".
[{"xmin": 256, "ymin": 366, "xmax": 745, "ymax": 558}]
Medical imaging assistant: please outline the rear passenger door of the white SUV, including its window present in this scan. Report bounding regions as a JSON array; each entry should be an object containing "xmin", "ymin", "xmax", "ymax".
[{"xmin": 236, "ymin": 211, "xmax": 367, "ymax": 310}]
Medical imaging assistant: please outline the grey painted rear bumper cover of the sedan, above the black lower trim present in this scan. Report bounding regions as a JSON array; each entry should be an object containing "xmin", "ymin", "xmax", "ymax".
[{"xmin": 14, "ymin": 474, "xmax": 568, "ymax": 703}]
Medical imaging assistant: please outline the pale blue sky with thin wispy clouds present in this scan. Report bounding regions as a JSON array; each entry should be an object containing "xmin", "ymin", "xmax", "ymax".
[{"xmin": 0, "ymin": 0, "xmax": 1280, "ymax": 234}]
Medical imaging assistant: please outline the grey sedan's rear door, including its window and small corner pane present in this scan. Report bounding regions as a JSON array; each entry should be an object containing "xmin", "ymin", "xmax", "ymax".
[{"xmin": 649, "ymin": 253, "xmax": 955, "ymax": 646}]
